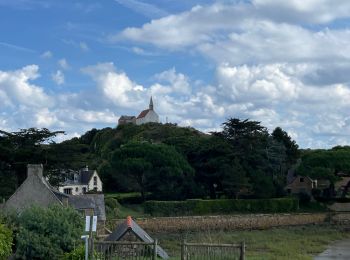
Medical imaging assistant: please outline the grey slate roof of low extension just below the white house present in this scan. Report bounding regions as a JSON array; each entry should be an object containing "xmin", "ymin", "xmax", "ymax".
[{"xmin": 68, "ymin": 194, "xmax": 106, "ymax": 221}]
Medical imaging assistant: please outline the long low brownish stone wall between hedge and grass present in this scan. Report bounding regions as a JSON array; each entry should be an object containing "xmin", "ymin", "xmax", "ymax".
[{"xmin": 108, "ymin": 213, "xmax": 329, "ymax": 232}]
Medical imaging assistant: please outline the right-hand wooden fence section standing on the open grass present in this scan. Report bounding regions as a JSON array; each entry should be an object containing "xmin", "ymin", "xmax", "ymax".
[{"xmin": 181, "ymin": 241, "xmax": 245, "ymax": 260}]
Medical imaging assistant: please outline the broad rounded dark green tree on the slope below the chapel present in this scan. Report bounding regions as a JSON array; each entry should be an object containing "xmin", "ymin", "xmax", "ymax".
[{"xmin": 110, "ymin": 142, "xmax": 194, "ymax": 200}]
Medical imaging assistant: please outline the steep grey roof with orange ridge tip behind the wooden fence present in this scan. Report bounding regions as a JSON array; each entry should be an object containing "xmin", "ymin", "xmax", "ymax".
[{"xmin": 105, "ymin": 216, "xmax": 169, "ymax": 259}]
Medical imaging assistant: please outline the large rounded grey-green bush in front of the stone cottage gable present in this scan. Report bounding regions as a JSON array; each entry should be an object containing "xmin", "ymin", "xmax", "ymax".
[{"xmin": 16, "ymin": 205, "xmax": 83, "ymax": 260}]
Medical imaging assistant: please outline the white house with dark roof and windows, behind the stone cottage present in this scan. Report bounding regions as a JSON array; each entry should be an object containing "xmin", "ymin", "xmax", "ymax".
[{"xmin": 58, "ymin": 166, "xmax": 102, "ymax": 195}]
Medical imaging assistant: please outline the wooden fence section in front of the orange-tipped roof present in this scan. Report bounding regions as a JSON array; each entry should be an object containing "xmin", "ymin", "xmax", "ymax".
[{"xmin": 90, "ymin": 240, "xmax": 158, "ymax": 260}]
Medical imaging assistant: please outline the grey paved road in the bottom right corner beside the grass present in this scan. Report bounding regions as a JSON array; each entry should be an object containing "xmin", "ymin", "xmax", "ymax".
[{"xmin": 314, "ymin": 239, "xmax": 350, "ymax": 260}]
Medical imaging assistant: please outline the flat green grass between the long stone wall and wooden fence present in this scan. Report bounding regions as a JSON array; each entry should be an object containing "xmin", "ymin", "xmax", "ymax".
[{"xmin": 154, "ymin": 225, "xmax": 350, "ymax": 260}]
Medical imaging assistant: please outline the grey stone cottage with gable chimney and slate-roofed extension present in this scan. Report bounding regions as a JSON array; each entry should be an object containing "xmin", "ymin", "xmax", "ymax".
[{"xmin": 3, "ymin": 164, "xmax": 106, "ymax": 235}]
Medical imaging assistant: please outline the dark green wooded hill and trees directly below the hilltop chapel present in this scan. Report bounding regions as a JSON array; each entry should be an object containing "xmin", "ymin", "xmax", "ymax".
[{"xmin": 0, "ymin": 118, "xmax": 300, "ymax": 200}]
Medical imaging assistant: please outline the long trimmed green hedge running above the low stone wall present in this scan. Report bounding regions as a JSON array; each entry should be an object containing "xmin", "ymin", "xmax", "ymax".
[{"xmin": 144, "ymin": 198, "xmax": 299, "ymax": 216}]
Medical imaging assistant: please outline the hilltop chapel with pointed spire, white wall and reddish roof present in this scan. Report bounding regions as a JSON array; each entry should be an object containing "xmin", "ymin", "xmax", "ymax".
[{"xmin": 118, "ymin": 97, "xmax": 159, "ymax": 125}]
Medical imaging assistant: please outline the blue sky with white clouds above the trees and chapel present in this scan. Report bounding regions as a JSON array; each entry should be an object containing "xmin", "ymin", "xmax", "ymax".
[{"xmin": 0, "ymin": 0, "xmax": 350, "ymax": 148}]
